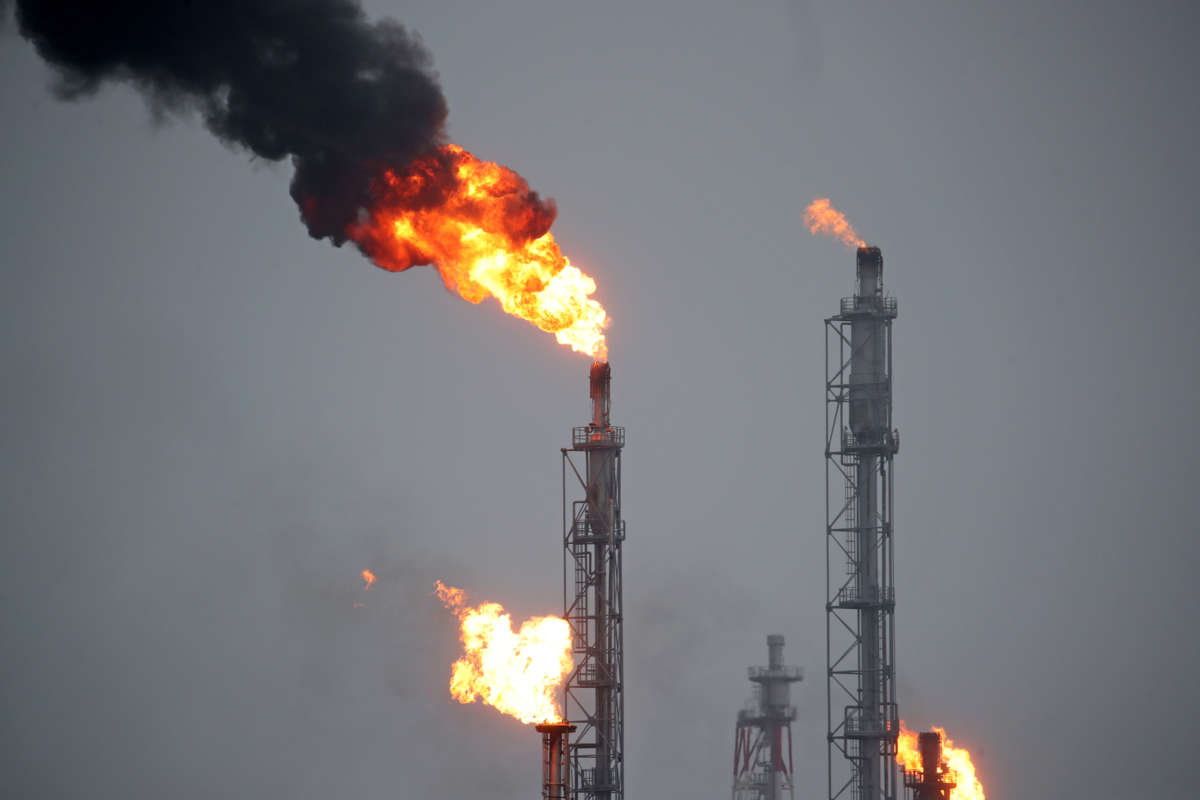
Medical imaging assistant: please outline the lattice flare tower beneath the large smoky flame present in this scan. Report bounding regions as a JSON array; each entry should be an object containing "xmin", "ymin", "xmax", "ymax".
[{"xmin": 563, "ymin": 361, "xmax": 625, "ymax": 800}]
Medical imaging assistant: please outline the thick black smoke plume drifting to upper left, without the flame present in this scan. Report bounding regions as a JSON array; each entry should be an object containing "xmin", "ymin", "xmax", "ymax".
[{"xmin": 8, "ymin": 0, "xmax": 446, "ymax": 245}]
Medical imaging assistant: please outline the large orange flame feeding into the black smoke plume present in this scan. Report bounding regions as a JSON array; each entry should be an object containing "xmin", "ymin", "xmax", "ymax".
[{"xmin": 347, "ymin": 144, "xmax": 608, "ymax": 359}]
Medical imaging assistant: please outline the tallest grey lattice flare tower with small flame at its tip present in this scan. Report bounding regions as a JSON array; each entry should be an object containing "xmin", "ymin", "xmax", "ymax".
[{"xmin": 826, "ymin": 247, "xmax": 899, "ymax": 800}]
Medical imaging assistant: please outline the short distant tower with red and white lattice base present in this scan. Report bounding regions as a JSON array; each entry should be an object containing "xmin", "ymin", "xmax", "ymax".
[{"xmin": 733, "ymin": 633, "xmax": 804, "ymax": 800}]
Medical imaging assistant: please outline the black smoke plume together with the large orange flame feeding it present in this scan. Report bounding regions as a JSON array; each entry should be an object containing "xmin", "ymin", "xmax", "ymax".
[{"xmin": 12, "ymin": 0, "xmax": 607, "ymax": 357}]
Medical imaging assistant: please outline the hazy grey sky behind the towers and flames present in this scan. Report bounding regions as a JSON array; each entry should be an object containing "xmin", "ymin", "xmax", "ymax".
[{"xmin": 0, "ymin": 0, "xmax": 1200, "ymax": 800}]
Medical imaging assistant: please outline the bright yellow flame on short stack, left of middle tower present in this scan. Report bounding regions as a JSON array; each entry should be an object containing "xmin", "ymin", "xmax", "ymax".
[{"xmin": 434, "ymin": 581, "xmax": 574, "ymax": 723}]
